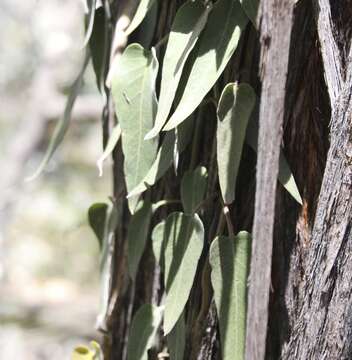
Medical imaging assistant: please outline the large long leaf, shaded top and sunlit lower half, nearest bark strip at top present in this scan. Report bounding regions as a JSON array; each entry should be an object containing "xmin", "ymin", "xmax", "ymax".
[{"xmin": 163, "ymin": 0, "xmax": 248, "ymax": 130}]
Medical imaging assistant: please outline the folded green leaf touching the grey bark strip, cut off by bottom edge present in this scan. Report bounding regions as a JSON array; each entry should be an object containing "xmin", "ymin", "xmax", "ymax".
[{"xmin": 209, "ymin": 231, "xmax": 251, "ymax": 360}]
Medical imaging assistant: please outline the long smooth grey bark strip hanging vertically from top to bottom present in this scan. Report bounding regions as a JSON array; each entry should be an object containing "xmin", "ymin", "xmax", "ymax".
[{"xmin": 246, "ymin": 0, "xmax": 294, "ymax": 360}]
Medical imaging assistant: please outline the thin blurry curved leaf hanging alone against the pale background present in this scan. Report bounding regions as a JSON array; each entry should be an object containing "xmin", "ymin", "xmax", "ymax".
[{"xmin": 26, "ymin": 51, "xmax": 90, "ymax": 181}]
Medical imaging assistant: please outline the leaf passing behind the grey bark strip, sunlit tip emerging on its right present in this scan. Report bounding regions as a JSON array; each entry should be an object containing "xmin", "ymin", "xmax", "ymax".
[{"xmin": 246, "ymin": 116, "xmax": 302, "ymax": 205}]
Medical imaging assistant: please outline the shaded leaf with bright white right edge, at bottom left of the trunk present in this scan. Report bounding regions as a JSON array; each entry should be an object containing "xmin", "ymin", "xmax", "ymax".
[{"xmin": 127, "ymin": 304, "xmax": 163, "ymax": 360}]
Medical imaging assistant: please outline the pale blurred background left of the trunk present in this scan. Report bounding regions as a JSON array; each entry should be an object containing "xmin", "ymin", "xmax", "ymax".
[{"xmin": 0, "ymin": 0, "xmax": 111, "ymax": 360}]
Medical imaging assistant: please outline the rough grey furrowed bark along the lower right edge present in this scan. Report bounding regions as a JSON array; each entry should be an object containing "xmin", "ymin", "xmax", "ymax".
[{"xmin": 283, "ymin": 35, "xmax": 352, "ymax": 360}]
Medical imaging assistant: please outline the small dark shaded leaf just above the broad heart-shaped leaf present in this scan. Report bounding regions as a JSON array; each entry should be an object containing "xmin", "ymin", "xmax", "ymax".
[{"xmin": 181, "ymin": 166, "xmax": 208, "ymax": 214}]
